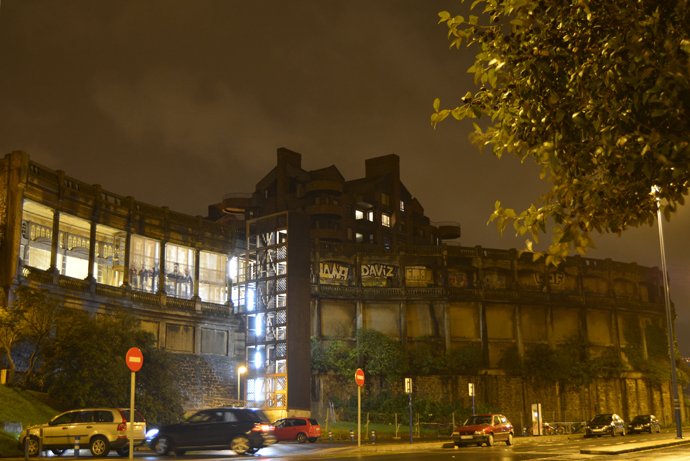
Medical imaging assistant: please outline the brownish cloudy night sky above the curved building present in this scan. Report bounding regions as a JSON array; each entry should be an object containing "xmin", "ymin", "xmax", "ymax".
[{"xmin": 0, "ymin": 0, "xmax": 690, "ymax": 356}]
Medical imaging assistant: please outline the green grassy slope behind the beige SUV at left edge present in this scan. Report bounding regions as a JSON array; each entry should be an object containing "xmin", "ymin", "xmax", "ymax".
[{"xmin": 0, "ymin": 385, "xmax": 60, "ymax": 456}]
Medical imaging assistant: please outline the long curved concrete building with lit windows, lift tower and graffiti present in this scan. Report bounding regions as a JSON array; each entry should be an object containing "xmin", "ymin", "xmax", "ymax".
[{"xmin": 0, "ymin": 149, "xmax": 671, "ymax": 424}]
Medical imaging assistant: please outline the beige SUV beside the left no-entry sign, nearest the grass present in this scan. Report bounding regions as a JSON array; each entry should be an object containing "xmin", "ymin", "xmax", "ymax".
[{"xmin": 18, "ymin": 408, "xmax": 146, "ymax": 456}]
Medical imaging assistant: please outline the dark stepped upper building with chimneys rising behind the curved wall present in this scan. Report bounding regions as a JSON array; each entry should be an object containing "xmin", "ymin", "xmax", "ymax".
[{"xmin": 209, "ymin": 148, "xmax": 460, "ymax": 246}]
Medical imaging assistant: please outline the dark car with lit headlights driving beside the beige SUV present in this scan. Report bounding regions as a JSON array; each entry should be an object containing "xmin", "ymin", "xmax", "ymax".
[{"xmin": 147, "ymin": 408, "xmax": 276, "ymax": 456}]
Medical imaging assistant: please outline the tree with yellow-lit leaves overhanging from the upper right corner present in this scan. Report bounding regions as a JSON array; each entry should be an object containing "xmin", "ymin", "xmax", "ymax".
[{"xmin": 431, "ymin": 0, "xmax": 690, "ymax": 264}]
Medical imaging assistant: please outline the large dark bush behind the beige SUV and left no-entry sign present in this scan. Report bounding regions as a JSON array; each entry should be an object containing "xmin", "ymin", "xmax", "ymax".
[{"xmin": 41, "ymin": 310, "xmax": 184, "ymax": 425}]
